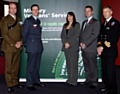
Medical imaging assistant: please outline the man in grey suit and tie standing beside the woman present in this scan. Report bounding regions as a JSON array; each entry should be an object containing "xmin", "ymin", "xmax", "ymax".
[{"xmin": 80, "ymin": 6, "xmax": 100, "ymax": 88}]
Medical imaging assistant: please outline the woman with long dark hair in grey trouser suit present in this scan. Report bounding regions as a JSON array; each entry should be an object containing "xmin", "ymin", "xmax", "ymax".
[{"xmin": 61, "ymin": 12, "xmax": 80, "ymax": 86}]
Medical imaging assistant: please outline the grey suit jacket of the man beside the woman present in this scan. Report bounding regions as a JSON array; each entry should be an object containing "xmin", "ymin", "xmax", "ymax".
[{"xmin": 80, "ymin": 18, "xmax": 100, "ymax": 52}]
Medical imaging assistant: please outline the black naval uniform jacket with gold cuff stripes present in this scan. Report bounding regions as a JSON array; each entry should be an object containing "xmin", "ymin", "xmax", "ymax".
[{"xmin": 98, "ymin": 18, "xmax": 120, "ymax": 57}]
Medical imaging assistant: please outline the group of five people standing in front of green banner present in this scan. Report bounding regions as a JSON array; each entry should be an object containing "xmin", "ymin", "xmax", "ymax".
[{"xmin": 1, "ymin": 3, "xmax": 120, "ymax": 94}]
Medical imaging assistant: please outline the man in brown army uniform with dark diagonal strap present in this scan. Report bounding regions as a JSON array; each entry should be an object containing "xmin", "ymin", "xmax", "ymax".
[{"xmin": 1, "ymin": 3, "xmax": 22, "ymax": 92}]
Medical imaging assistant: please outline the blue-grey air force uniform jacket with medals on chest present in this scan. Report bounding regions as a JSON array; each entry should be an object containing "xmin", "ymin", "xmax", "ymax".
[{"xmin": 22, "ymin": 16, "xmax": 43, "ymax": 52}]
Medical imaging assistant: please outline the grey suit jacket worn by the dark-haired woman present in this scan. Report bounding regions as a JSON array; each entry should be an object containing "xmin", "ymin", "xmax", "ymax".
[{"xmin": 61, "ymin": 23, "xmax": 80, "ymax": 51}]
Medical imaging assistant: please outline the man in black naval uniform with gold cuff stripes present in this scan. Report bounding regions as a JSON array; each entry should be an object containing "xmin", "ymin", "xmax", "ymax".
[{"xmin": 98, "ymin": 6, "xmax": 120, "ymax": 94}]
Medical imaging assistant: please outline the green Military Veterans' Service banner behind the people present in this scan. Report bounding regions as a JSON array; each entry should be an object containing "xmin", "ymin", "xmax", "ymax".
[{"xmin": 19, "ymin": 0, "xmax": 101, "ymax": 79}]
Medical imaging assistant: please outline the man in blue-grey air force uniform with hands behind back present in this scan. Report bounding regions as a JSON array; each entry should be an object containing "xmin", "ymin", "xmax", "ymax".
[{"xmin": 22, "ymin": 4, "xmax": 44, "ymax": 91}]
